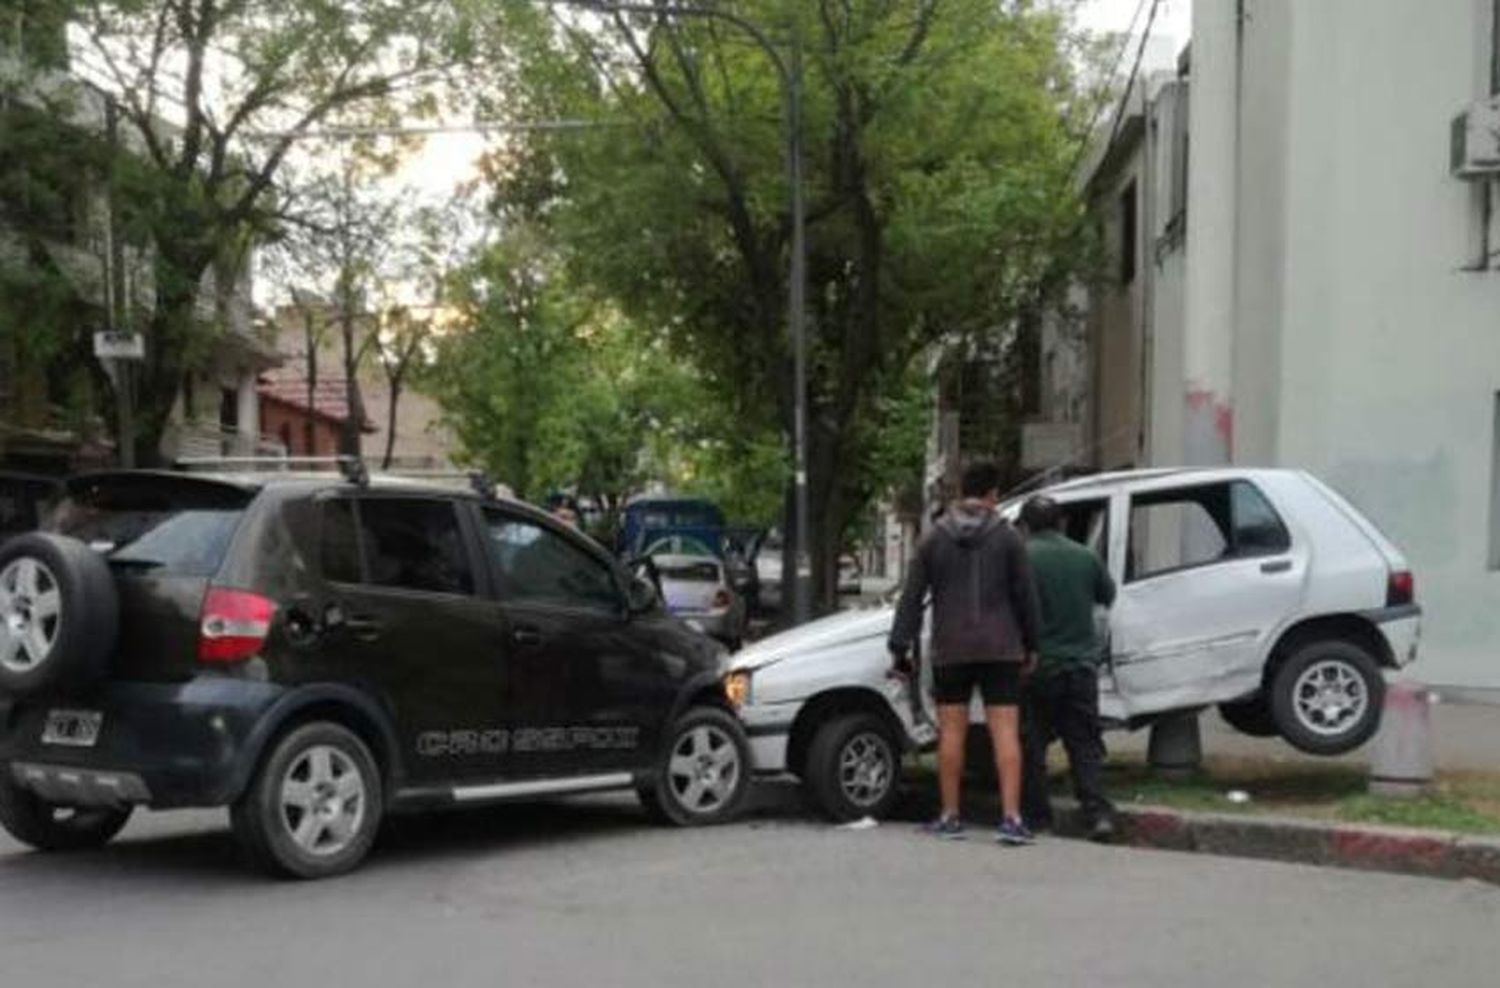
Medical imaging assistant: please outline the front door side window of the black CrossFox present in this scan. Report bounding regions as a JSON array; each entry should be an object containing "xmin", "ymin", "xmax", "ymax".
[{"xmin": 485, "ymin": 511, "xmax": 621, "ymax": 610}]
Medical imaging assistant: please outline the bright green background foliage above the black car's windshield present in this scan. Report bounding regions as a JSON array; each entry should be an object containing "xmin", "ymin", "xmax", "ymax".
[{"xmin": 425, "ymin": 226, "xmax": 720, "ymax": 508}]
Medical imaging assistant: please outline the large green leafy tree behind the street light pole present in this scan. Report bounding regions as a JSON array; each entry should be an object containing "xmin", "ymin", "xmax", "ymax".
[{"xmin": 498, "ymin": 0, "xmax": 1091, "ymax": 603}]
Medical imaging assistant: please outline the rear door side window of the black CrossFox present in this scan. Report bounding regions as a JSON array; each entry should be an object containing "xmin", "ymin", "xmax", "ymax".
[{"xmin": 352, "ymin": 498, "xmax": 474, "ymax": 595}]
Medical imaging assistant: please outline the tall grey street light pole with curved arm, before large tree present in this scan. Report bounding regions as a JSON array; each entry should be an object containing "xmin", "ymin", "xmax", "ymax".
[{"xmin": 545, "ymin": 0, "xmax": 812, "ymax": 624}]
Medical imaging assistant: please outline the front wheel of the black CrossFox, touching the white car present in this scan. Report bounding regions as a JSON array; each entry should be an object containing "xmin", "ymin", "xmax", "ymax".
[{"xmin": 636, "ymin": 706, "xmax": 752, "ymax": 826}]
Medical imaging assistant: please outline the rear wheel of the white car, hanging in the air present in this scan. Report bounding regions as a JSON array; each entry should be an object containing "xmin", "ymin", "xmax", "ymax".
[{"xmin": 1271, "ymin": 639, "xmax": 1386, "ymax": 754}]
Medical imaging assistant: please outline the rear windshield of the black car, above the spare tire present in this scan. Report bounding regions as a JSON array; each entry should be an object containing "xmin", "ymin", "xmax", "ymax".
[{"xmin": 48, "ymin": 477, "xmax": 254, "ymax": 577}]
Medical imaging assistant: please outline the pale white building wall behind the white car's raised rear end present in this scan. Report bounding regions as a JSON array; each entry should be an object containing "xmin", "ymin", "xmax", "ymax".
[{"xmin": 1185, "ymin": 0, "xmax": 1500, "ymax": 688}]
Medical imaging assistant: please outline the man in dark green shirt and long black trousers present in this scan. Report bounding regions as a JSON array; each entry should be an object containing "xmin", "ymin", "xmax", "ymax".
[{"xmin": 1022, "ymin": 496, "xmax": 1115, "ymax": 841}]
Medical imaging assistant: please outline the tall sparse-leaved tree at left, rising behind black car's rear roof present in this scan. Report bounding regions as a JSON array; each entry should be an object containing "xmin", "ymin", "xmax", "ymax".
[{"xmin": 75, "ymin": 0, "xmax": 489, "ymax": 462}]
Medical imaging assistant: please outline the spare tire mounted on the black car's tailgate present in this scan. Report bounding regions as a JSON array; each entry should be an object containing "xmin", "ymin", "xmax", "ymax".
[{"xmin": 0, "ymin": 532, "xmax": 120, "ymax": 696}]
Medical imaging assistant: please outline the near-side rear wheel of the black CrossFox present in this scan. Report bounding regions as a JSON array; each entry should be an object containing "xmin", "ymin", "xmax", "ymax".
[{"xmin": 230, "ymin": 721, "xmax": 386, "ymax": 879}]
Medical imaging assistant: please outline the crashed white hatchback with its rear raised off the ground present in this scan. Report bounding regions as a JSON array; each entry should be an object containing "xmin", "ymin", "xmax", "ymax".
[{"xmin": 731, "ymin": 469, "xmax": 1422, "ymax": 819}]
